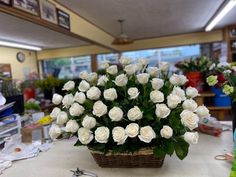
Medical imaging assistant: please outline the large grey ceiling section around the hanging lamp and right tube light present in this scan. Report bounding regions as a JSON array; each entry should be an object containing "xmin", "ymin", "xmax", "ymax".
[{"xmin": 56, "ymin": 0, "xmax": 236, "ymax": 39}]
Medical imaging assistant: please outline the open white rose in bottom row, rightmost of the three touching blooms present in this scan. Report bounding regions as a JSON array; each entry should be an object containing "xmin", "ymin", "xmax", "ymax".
[{"xmin": 138, "ymin": 126, "xmax": 156, "ymax": 143}]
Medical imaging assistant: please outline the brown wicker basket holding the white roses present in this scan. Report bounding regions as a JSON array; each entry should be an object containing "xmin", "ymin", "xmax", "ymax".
[{"xmin": 90, "ymin": 149, "xmax": 165, "ymax": 168}]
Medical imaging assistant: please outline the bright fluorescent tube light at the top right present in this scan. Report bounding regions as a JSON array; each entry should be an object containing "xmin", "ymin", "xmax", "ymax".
[{"xmin": 205, "ymin": 0, "xmax": 236, "ymax": 31}]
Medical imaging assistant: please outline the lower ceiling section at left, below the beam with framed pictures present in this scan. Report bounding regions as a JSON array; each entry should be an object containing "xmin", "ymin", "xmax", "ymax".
[{"xmin": 0, "ymin": 13, "xmax": 88, "ymax": 49}]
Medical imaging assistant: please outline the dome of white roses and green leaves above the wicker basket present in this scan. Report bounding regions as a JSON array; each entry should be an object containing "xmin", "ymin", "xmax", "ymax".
[{"xmin": 49, "ymin": 58, "xmax": 210, "ymax": 159}]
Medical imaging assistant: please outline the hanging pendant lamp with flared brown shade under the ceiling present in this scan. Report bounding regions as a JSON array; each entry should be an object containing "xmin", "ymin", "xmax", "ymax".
[{"xmin": 112, "ymin": 20, "xmax": 133, "ymax": 45}]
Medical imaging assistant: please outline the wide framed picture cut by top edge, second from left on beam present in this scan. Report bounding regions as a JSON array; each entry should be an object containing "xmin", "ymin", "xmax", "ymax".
[{"xmin": 13, "ymin": 0, "xmax": 39, "ymax": 15}]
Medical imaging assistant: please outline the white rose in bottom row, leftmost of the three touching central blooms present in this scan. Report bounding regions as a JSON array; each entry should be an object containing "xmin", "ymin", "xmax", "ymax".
[{"xmin": 112, "ymin": 127, "xmax": 128, "ymax": 145}]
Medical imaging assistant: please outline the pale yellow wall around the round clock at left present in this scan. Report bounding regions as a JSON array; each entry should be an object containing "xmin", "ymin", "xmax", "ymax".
[{"xmin": 0, "ymin": 47, "xmax": 37, "ymax": 79}]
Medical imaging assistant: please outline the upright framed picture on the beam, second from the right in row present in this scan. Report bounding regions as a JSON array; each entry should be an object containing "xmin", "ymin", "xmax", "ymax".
[{"xmin": 40, "ymin": 0, "xmax": 57, "ymax": 24}]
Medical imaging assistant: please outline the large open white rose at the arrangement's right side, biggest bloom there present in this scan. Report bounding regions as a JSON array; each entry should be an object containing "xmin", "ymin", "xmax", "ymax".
[{"xmin": 180, "ymin": 110, "xmax": 199, "ymax": 130}]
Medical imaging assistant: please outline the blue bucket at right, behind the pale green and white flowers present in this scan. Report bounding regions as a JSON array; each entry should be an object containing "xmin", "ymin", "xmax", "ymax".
[{"xmin": 211, "ymin": 87, "xmax": 231, "ymax": 107}]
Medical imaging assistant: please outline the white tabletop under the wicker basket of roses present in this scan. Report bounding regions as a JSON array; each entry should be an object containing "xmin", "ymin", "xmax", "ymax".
[{"xmin": 1, "ymin": 125, "xmax": 233, "ymax": 177}]
